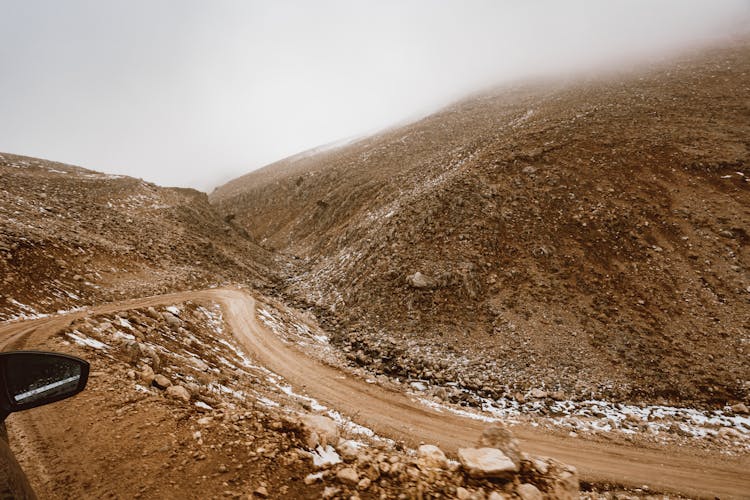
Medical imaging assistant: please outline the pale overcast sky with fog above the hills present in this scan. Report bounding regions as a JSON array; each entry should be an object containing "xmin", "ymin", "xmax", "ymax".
[{"xmin": 0, "ymin": 0, "xmax": 750, "ymax": 191}]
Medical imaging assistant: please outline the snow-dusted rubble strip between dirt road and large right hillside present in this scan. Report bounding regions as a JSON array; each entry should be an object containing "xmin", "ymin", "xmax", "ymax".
[{"xmin": 258, "ymin": 298, "xmax": 750, "ymax": 456}]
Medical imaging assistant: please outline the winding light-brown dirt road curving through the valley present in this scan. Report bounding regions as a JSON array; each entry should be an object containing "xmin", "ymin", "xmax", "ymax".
[{"xmin": 0, "ymin": 289, "xmax": 750, "ymax": 498}]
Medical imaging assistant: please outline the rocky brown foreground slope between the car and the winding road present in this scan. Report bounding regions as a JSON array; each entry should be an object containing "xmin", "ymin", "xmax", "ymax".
[{"xmin": 5, "ymin": 302, "xmax": 592, "ymax": 499}]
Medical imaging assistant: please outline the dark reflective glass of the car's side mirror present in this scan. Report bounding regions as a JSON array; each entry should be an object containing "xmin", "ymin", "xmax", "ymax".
[{"xmin": 5, "ymin": 354, "xmax": 81, "ymax": 406}]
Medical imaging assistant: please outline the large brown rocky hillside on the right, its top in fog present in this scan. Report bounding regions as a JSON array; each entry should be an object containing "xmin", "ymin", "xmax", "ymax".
[{"xmin": 210, "ymin": 38, "xmax": 750, "ymax": 406}]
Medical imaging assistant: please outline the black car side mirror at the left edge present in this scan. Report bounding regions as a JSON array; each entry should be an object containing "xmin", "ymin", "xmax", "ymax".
[{"xmin": 0, "ymin": 351, "xmax": 89, "ymax": 420}]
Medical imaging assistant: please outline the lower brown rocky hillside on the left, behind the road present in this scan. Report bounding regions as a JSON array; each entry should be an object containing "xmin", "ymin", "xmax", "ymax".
[{"xmin": 0, "ymin": 154, "xmax": 271, "ymax": 320}]
